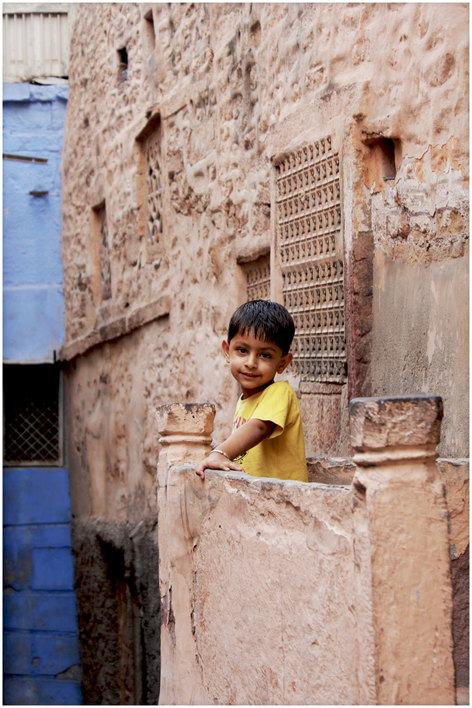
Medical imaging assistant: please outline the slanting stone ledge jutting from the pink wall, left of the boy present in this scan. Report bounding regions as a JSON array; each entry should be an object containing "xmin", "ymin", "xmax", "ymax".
[{"xmin": 58, "ymin": 295, "xmax": 170, "ymax": 361}]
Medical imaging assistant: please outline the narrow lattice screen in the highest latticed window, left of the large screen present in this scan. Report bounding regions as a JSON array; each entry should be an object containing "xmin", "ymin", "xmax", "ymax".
[{"xmin": 144, "ymin": 129, "xmax": 162, "ymax": 247}]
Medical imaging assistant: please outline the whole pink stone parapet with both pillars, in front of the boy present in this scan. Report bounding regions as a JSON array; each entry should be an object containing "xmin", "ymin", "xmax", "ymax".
[{"xmin": 158, "ymin": 397, "xmax": 455, "ymax": 704}]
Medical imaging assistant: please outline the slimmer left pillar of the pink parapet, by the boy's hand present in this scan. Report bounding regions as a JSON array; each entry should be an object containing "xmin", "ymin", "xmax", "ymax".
[{"xmin": 157, "ymin": 403, "xmax": 215, "ymax": 705}]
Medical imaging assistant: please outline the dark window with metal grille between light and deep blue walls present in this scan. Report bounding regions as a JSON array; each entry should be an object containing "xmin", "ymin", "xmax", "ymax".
[{"xmin": 3, "ymin": 364, "xmax": 62, "ymax": 466}]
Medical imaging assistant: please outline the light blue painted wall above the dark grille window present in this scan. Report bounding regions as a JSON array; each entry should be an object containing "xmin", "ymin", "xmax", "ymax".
[{"xmin": 3, "ymin": 84, "xmax": 68, "ymax": 362}]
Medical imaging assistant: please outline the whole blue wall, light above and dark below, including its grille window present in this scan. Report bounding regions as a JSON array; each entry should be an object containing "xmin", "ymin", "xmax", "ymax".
[{"xmin": 3, "ymin": 83, "xmax": 81, "ymax": 705}]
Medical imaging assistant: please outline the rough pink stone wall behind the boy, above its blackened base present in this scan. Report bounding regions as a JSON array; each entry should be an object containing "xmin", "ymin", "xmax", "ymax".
[{"xmin": 61, "ymin": 3, "xmax": 468, "ymax": 704}]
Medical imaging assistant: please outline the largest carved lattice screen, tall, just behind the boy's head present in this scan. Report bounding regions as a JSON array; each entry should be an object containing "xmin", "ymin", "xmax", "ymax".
[{"xmin": 275, "ymin": 137, "xmax": 346, "ymax": 383}]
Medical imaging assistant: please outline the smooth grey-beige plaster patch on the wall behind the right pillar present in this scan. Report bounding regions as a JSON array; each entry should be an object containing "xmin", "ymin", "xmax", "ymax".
[{"xmin": 372, "ymin": 221, "xmax": 469, "ymax": 457}]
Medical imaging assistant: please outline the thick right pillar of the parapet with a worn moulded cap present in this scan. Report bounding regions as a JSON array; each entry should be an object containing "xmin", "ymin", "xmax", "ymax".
[{"xmin": 350, "ymin": 396, "xmax": 455, "ymax": 705}]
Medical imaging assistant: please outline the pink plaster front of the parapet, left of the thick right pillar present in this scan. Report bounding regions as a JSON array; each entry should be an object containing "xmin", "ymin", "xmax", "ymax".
[{"xmin": 160, "ymin": 468, "xmax": 375, "ymax": 705}]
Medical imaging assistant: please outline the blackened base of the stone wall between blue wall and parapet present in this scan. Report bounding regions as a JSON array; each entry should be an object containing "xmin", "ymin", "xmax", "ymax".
[{"xmin": 74, "ymin": 519, "xmax": 161, "ymax": 705}]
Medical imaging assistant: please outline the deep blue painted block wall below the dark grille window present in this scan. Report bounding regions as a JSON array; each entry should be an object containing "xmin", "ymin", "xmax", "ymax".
[{"xmin": 3, "ymin": 467, "xmax": 81, "ymax": 705}]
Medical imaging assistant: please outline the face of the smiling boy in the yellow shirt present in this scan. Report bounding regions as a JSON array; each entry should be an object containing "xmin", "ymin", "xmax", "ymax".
[{"xmin": 223, "ymin": 332, "xmax": 292, "ymax": 398}]
